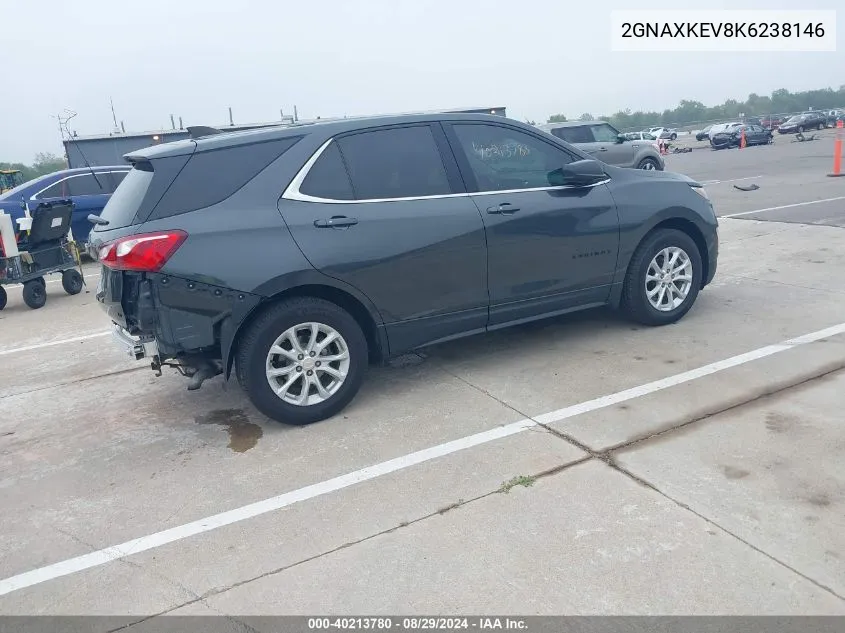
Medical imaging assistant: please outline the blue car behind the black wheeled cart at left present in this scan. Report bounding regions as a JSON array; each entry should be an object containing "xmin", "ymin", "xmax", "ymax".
[{"xmin": 0, "ymin": 165, "xmax": 130, "ymax": 244}]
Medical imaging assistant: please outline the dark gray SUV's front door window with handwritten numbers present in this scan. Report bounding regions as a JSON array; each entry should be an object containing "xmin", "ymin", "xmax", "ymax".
[{"xmin": 452, "ymin": 124, "xmax": 573, "ymax": 191}]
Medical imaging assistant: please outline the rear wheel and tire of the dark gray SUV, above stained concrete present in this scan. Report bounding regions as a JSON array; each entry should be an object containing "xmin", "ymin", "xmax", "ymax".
[{"xmin": 236, "ymin": 297, "xmax": 369, "ymax": 425}]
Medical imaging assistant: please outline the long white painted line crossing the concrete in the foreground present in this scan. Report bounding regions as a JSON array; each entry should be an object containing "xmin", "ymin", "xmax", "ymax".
[{"xmin": 0, "ymin": 323, "xmax": 845, "ymax": 596}]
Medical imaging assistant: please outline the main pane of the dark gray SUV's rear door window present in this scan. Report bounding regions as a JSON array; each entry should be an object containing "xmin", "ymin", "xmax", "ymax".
[{"xmin": 338, "ymin": 125, "xmax": 452, "ymax": 200}]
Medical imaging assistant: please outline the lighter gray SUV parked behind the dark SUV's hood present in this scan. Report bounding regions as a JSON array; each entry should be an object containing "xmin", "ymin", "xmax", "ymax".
[{"xmin": 539, "ymin": 121, "xmax": 664, "ymax": 171}]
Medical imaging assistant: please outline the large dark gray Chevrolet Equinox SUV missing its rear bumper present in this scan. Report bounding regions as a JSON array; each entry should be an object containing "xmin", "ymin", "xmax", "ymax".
[{"xmin": 90, "ymin": 114, "xmax": 718, "ymax": 424}]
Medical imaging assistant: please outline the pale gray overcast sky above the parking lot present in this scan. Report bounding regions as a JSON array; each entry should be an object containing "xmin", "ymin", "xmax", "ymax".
[{"xmin": 0, "ymin": 0, "xmax": 845, "ymax": 163}]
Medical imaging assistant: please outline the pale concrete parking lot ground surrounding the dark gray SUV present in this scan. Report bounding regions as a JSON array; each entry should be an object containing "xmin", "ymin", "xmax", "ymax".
[{"xmin": 0, "ymin": 132, "xmax": 845, "ymax": 629}]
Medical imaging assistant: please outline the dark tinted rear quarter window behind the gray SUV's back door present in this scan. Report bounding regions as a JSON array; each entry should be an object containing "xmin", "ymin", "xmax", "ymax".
[{"xmin": 147, "ymin": 136, "xmax": 302, "ymax": 220}]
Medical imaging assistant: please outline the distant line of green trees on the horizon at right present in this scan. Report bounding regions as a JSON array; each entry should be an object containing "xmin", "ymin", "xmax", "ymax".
[{"xmin": 548, "ymin": 84, "xmax": 845, "ymax": 130}]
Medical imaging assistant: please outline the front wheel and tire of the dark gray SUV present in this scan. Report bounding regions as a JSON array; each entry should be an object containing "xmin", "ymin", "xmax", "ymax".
[{"xmin": 620, "ymin": 229, "xmax": 703, "ymax": 326}]
